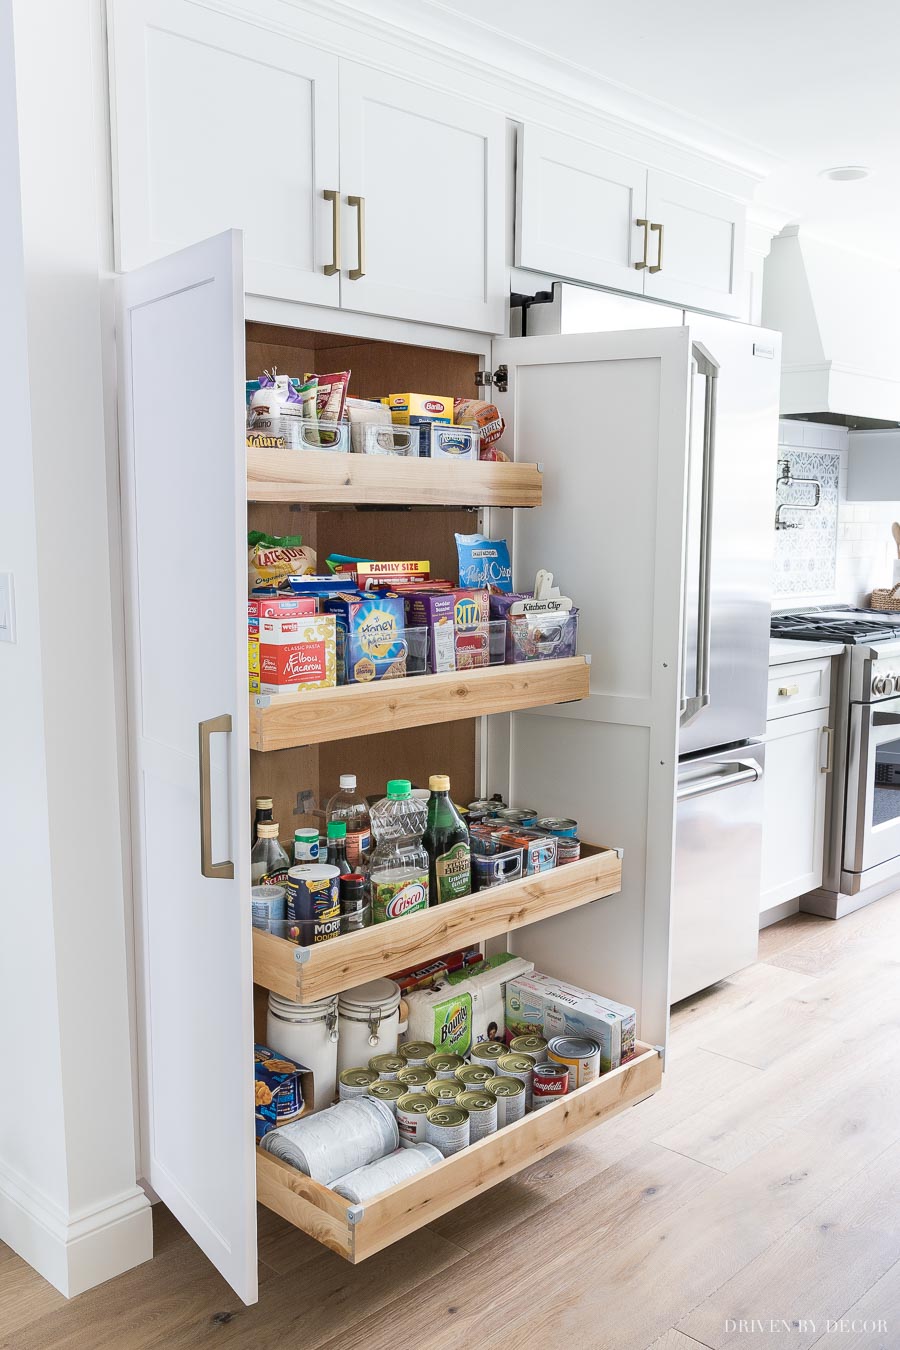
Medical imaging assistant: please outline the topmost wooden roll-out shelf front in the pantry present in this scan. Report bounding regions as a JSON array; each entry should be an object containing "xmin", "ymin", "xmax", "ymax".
[{"xmin": 247, "ymin": 447, "xmax": 542, "ymax": 510}]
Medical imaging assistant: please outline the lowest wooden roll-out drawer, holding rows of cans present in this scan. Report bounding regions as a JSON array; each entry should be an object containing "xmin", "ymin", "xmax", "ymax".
[{"xmin": 256, "ymin": 1036, "xmax": 663, "ymax": 1264}]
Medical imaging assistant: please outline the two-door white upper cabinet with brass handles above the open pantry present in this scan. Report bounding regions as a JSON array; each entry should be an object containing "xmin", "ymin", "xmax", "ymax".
[{"xmin": 111, "ymin": 0, "xmax": 507, "ymax": 332}]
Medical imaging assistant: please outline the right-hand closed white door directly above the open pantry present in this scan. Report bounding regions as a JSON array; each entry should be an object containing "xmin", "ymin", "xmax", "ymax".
[{"xmin": 340, "ymin": 61, "xmax": 507, "ymax": 332}]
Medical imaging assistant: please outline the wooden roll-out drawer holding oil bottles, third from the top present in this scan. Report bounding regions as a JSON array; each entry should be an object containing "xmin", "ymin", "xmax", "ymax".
[{"xmin": 254, "ymin": 844, "xmax": 622, "ymax": 1004}]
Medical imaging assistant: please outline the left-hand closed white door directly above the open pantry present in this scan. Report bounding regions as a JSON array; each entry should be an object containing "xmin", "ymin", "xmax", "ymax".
[{"xmin": 111, "ymin": 0, "xmax": 340, "ymax": 305}]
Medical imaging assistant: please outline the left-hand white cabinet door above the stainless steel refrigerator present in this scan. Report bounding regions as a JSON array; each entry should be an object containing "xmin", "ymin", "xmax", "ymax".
[{"xmin": 515, "ymin": 126, "xmax": 649, "ymax": 294}]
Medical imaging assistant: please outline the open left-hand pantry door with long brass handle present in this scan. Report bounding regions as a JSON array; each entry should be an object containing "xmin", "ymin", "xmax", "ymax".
[{"xmin": 120, "ymin": 231, "xmax": 256, "ymax": 1303}]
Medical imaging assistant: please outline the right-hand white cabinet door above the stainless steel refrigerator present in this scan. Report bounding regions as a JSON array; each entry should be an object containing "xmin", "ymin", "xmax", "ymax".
[{"xmin": 642, "ymin": 169, "xmax": 746, "ymax": 315}]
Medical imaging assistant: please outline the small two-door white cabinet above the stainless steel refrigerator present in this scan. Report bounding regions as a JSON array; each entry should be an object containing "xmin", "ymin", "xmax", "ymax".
[{"xmin": 515, "ymin": 126, "xmax": 746, "ymax": 315}]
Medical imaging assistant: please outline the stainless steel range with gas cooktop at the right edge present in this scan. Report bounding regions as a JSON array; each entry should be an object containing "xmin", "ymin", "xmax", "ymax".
[{"xmin": 772, "ymin": 605, "xmax": 900, "ymax": 918}]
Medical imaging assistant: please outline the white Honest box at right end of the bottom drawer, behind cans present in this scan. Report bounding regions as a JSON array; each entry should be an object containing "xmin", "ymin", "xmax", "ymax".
[{"xmin": 506, "ymin": 972, "xmax": 636, "ymax": 1073}]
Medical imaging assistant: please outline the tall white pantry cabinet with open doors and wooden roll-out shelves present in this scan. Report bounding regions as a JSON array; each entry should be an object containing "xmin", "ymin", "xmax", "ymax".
[{"xmin": 120, "ymin": 231, "xmax": 691, "ymax": 1301}]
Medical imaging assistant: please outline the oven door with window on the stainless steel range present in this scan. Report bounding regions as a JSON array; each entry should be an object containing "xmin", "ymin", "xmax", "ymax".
[{"xmin": 843, "ymin": 698, "xmax": 900, "ymax": 872}]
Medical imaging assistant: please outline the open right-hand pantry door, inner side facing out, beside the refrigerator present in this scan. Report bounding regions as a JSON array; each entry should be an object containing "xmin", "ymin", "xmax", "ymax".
[{"xmin": 487, "ymin": 328, "xmax": 691, "ymax": 1045}]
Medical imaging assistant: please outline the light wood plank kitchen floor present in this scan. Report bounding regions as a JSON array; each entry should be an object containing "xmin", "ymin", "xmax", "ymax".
[{"xmin": 0, "ymin": 892, "xmax": 900, "ymax": 1350}]
